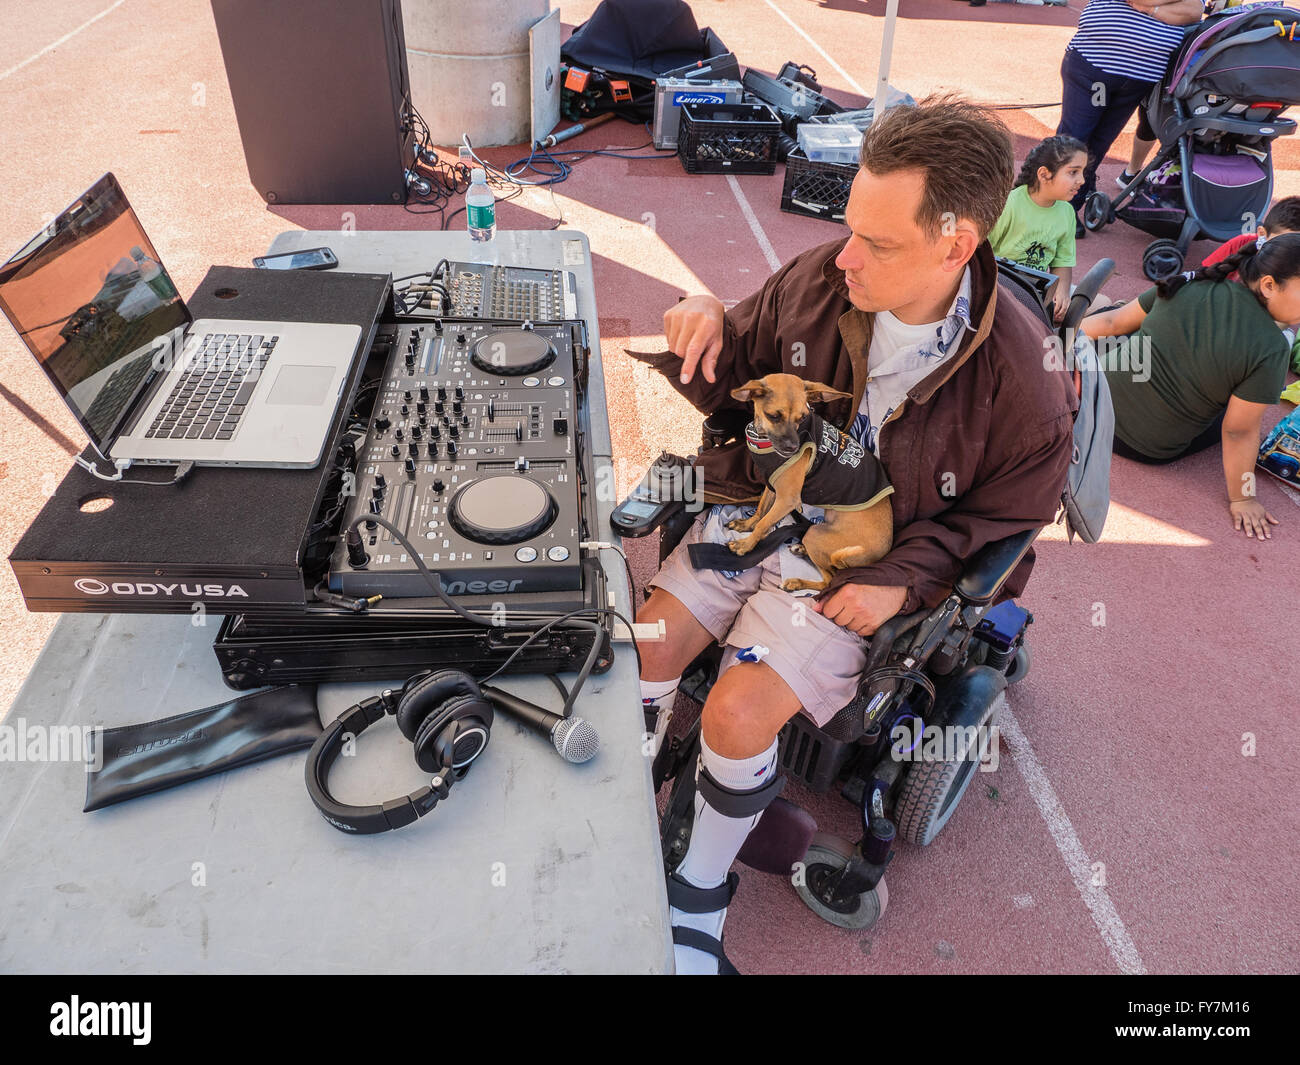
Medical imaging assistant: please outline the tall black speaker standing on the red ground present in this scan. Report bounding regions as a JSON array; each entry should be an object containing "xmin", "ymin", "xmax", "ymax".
[{"xmin": 212, "ymin": 0, "xmax": 415, "ymax": 203}]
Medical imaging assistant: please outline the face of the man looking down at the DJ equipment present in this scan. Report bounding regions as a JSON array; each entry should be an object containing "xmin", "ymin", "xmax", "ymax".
[{"xmin": 835, "ymin": 169, "xmax": 979, "ymax": 315}]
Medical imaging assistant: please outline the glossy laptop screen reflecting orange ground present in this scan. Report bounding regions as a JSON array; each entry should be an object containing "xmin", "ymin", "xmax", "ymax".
[{"xmin": 0, "ymin": 174, "xmax": 191, "ymax": 454}]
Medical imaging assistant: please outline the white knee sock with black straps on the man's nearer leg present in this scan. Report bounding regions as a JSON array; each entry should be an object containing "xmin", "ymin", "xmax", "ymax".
[{"xmin": 668, "ymin": 736, "xmax": 776, "ymax": 975}]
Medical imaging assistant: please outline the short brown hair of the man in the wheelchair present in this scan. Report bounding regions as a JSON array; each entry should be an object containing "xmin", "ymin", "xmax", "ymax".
[{"xmin": 861, "ymin": 95, "xmax": 1015, "ymax": 241}]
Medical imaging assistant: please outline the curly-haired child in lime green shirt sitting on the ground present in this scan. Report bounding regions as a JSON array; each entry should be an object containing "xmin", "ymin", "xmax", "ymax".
[{"xmin": 988, "ymin": 137, "xmax": 1088, "ymax": 321}]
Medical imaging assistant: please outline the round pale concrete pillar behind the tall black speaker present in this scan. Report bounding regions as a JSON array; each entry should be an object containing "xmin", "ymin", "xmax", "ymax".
[{"xmin": 402, "ymin": 0, "xmax": 551, "ymax": 148}]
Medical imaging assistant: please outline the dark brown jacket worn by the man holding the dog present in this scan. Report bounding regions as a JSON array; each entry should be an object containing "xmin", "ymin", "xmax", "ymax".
[{"xmin": 629, "ymin": 241, "xmax": 1078, "ymax": 612}]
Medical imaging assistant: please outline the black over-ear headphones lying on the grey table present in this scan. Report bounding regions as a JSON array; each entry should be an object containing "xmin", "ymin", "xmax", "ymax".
[{"xmin": 307, "ymin": 670, "xmax": 493, "ymax": 835}]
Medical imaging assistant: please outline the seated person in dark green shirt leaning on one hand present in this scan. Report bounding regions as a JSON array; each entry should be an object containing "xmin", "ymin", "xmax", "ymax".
[{"xmin": 1079, "ymin": 233, "xmax": 1300, "ymax": 540}]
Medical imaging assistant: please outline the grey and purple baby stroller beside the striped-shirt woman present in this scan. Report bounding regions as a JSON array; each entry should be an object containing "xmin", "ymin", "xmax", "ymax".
[{"xmin": 1083, "ymin": 7, "xmax": 1300, "ymax": 281}]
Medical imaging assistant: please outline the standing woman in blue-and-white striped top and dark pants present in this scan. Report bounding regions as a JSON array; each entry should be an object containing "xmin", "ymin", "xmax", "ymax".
[{"xmin": 1057, "ymin": 0, "xmax": 1203, "ymax": 237}]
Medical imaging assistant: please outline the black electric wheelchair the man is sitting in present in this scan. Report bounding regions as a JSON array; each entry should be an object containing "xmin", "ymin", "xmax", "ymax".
[{"xmin": 613, "ymin": 259, "xmax": 1114, "ymax": 928}]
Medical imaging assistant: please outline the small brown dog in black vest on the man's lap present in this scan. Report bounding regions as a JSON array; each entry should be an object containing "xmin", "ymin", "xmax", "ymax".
[{"xmin": 727, "ymin": 373, "xmax": 893, "ymax": 592}]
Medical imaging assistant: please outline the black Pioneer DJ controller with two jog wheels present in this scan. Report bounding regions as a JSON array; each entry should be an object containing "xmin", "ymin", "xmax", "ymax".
[{"xmin": 328, "ymin": 319, "xmax": 585, "ymax": 598}]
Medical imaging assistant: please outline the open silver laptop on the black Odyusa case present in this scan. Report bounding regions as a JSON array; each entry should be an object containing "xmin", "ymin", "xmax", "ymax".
[{"xmin": 0, "ymin": 174, "xmax": 361, "ymax": 467}]
